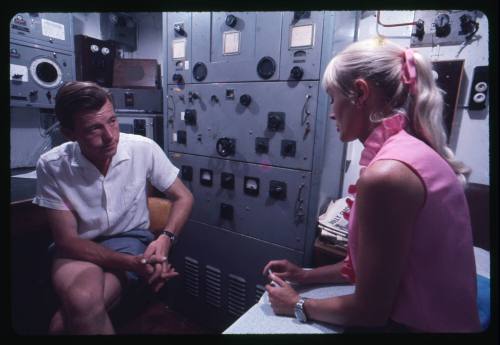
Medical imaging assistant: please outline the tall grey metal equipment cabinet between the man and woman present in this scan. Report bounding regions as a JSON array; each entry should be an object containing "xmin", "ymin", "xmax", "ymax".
[{"xmin": 163, "ymin": 11, "xmax": 342, "ymax": 328}]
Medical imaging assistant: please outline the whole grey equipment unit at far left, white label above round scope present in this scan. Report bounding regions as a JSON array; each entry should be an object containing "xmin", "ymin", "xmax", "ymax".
[{"xmin": 9, "ymin": 13, "xmax": 75, "ymax": 108}]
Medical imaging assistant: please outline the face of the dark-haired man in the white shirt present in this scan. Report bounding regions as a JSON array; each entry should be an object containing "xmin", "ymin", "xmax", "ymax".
[{"xmin": 66, "ymin": 100, "xmax": 120, "ymax": 163}]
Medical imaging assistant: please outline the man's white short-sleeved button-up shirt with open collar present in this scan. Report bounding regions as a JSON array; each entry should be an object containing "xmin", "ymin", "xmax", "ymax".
[{"xmin": 33, "ymin": 133, "xmax": 179, "ymax": 239}]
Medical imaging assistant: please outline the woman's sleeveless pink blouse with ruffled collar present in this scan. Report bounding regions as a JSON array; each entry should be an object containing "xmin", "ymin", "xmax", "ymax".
[{"xmin": 343, "ymin": 114, "xmax": 480, "ymax": 332}]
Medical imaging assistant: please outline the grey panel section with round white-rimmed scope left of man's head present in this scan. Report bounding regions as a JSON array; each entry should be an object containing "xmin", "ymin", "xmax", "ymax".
[{"xmin": 10, "ymin": 40, "xmax": 75, "ymax": 108}]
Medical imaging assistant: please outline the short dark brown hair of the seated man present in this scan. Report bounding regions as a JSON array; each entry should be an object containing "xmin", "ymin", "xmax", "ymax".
[{"xmin": 55, "ymin": 81, "xmax": 113, "ymax": 129}]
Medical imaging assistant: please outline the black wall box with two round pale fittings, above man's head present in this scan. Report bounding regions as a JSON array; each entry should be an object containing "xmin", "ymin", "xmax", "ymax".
[{"xmin": 75, "ymin": 35, "xmax": 116, "ymax": 87}]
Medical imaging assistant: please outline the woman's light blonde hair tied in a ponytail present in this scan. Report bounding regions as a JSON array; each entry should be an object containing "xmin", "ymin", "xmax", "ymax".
[{"xmin": 323, "ymin": 38, "xmax": 471, "ymax": 183}]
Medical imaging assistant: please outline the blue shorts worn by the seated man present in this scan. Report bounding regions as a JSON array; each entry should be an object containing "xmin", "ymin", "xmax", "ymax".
[{"xmin": 49, "ymin": 229, "xmax": 154, "ymax": 282}]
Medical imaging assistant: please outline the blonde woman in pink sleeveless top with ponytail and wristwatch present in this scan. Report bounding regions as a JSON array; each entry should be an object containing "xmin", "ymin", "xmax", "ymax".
[{"xmin": 264, "ymin": 39, "xmax": 480, "ymax": 332}]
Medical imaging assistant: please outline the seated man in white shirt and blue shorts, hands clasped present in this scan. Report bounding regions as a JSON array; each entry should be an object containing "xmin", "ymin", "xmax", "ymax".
[{"xmin": 33, "ymin": 82, "xmax": 193, "ymax": 334}]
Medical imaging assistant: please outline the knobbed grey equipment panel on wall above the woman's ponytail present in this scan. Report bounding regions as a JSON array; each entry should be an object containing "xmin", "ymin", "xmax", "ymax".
[{"xmin": 410, "ymin": 10, "xmax": 482, "ymax": 47}]
